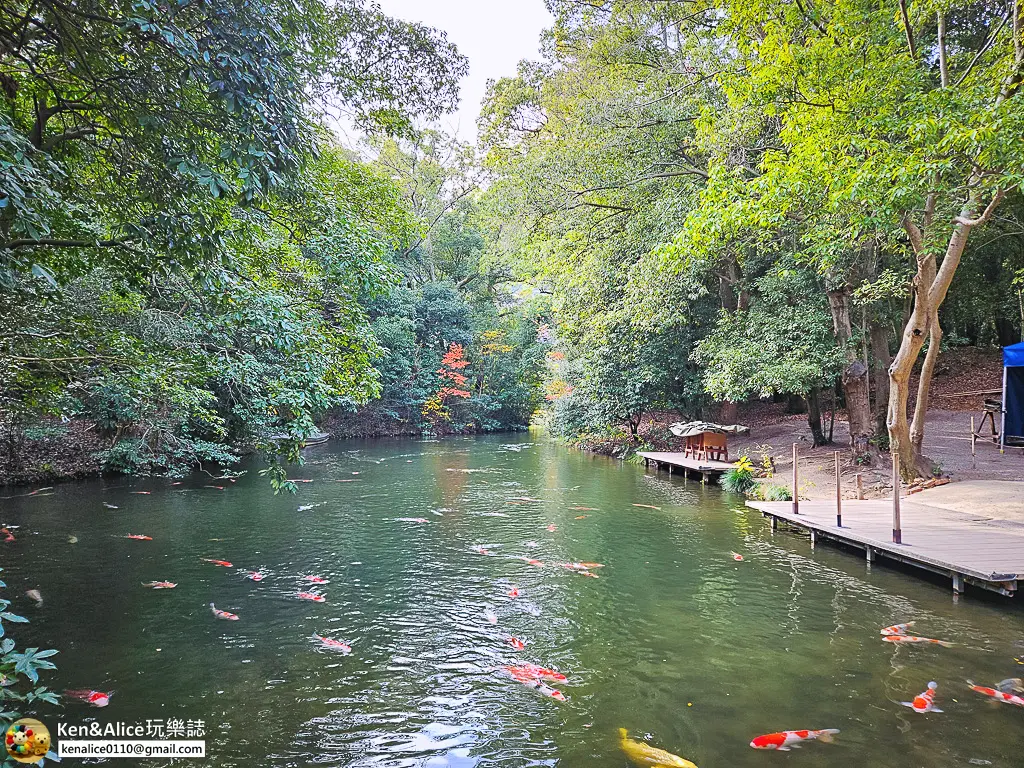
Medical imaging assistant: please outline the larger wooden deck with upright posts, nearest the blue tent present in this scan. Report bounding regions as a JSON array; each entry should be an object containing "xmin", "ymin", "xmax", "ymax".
[{"xmin": 746, "ymin": 499, "xmax": 1024, "ymax": 596}]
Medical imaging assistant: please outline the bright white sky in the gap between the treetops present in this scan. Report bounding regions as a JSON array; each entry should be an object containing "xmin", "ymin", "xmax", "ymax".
[{"xmin": 378, "ymin": 0, "xmax": 552, "ymax": 141}]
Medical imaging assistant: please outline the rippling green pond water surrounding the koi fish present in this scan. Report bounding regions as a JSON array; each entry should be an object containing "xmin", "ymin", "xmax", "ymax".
[{"xmin": 0, "ymin": 435, "xmax": 1024, "ymax": 768}]
